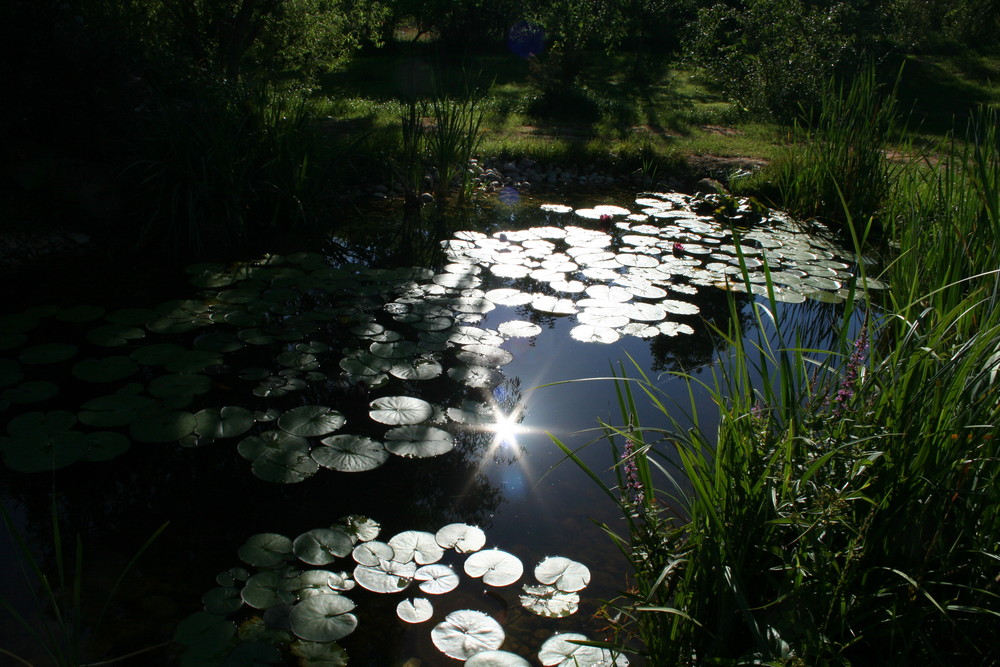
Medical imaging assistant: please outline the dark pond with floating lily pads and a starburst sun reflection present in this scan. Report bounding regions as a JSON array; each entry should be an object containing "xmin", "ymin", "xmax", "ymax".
[{"xmin": 0, "ymin": 192, "xmax": 882, "ymax": 666}]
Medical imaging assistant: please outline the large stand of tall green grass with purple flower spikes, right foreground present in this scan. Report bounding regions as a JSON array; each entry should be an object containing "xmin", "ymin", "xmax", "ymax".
[{"xmin": 564, "ymin": 105, "xmax": 1000, "ymax": 666}]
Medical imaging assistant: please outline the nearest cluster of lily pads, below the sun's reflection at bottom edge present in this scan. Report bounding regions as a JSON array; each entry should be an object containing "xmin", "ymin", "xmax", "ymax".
[{"xmin": 176, "ymin": 516, "xmax": 628, "ymax": 667}]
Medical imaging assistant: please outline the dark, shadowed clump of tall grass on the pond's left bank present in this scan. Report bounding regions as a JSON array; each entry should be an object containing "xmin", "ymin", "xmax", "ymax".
[{"xmin": 132, "ymin": 81, "xmax": 324, "ymax": 254}]
